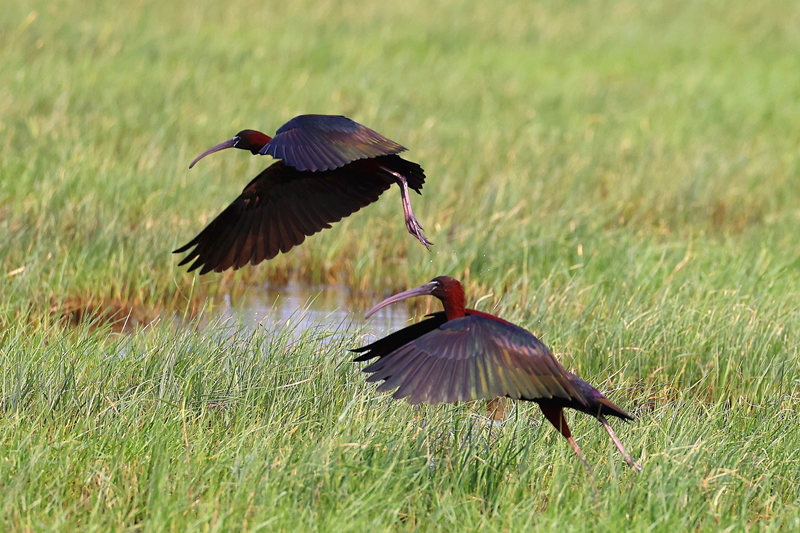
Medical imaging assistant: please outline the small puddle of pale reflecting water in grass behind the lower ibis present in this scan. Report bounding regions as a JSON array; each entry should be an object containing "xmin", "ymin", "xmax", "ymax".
[{"xmin": 215, "ymin": 282, "xmax": 410, "ymax": 340}]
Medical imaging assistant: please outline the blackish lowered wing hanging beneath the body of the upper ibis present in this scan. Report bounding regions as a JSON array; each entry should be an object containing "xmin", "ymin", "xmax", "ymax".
[{"xmin": 173, "ymin": 161, "xmax": 392, "ymax": 274}]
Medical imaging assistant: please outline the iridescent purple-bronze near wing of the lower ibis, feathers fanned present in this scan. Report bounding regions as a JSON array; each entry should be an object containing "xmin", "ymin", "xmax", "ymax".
[{"xmin": 364, "ymin": 315, "xmax": 585, "ymax": 404}]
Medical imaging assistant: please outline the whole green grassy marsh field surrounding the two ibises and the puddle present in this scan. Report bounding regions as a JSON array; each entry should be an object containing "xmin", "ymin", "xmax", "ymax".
[{"xmin": 0, "ymin": 0, "xmax": 800, "ymax": 531}]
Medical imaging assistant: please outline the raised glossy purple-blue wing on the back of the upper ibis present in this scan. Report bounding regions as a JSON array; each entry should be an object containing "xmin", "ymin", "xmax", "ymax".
[{"xmin": 260, "ymin": 115, "xmax": 405, "ymax": 172}]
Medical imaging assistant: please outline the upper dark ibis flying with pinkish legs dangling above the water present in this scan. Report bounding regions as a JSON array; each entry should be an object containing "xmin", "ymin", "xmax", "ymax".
[{"xmin": 173, "ymin": 115, "xmax": 432, "ymax": 274}]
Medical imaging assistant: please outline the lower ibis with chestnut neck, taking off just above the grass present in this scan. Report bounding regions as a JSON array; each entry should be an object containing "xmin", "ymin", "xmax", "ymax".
[{"xmin": 351, "ymin": 276, "xmax": 641, "ymax": 471}]
